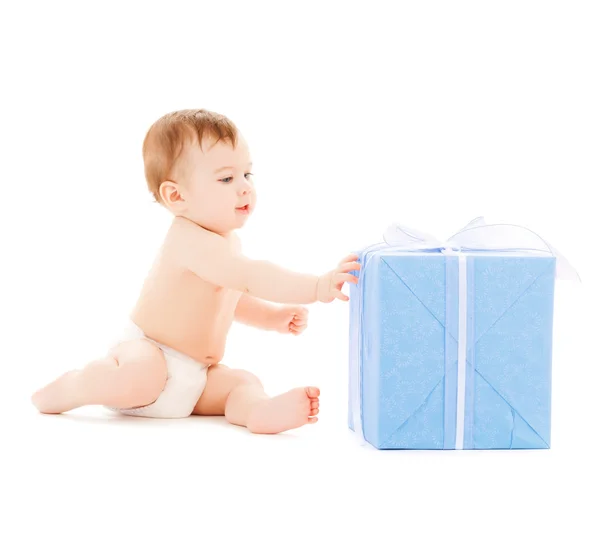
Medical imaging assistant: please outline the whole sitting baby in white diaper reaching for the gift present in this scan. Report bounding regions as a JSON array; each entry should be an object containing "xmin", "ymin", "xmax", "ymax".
[{"xmin": 32, "ymin": 109, "xmax": 360, "ymax": 434}]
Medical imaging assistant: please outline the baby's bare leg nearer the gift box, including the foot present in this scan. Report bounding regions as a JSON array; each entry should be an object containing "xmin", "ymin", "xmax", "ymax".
[{"xmin": 194, "ymin": 364, "xmax": 320, "ymax": 434}]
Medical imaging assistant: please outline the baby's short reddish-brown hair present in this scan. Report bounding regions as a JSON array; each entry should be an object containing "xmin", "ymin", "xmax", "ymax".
[{"xmin": 142, "ymin": 109, "xmax": 238, "ymax": 202}]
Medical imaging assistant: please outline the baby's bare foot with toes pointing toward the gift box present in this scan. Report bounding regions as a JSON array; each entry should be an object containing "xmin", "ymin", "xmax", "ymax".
[{"xmin": 246, "ymin": 387, "xmax": 321, "ymax": 434}]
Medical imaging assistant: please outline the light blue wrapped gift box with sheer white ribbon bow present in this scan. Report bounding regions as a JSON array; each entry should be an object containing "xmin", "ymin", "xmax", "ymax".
[{"xmin": 348, "ymin": 219, "xmax": 578, "ymax": 449}]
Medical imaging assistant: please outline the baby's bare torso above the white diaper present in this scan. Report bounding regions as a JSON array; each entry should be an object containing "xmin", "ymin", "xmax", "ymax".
[{"xmin": 131, "ymin": 219, "xmax": 241, "ymax": 364}]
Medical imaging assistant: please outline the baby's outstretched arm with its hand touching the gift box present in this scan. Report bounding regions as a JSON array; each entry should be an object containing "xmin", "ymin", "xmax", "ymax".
[{"xmin": 173, "ymin": 220, "xmax": 360, "ymax": 304}]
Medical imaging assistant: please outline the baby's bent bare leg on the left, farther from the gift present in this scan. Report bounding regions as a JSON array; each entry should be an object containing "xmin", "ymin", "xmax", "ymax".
[{"xmin": 32, "ymin": 339, "xmax": 167, "ymax": 413}]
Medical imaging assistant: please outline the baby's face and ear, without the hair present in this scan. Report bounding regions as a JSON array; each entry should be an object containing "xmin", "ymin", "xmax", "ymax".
[{"xmin": 177, "ymin": 136, "xmax": 256, "ymax": 235}]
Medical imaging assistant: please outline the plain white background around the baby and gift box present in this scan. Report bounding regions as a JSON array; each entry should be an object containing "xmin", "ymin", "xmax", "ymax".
[{"xmin": 0, "ymin": 0, "xmax": 600, "ymax": 540}]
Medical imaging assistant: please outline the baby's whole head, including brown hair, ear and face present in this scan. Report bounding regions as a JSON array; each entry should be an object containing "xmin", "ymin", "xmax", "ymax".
[{"xmin": 143, "ymin": 109, "xmax": 256, "ymax": 235}]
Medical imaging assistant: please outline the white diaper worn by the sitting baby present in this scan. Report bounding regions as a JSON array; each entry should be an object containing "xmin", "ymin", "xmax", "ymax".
[{"xmin": 108, "ymin": 321, "xmax": 209, "ymax": 419}]
